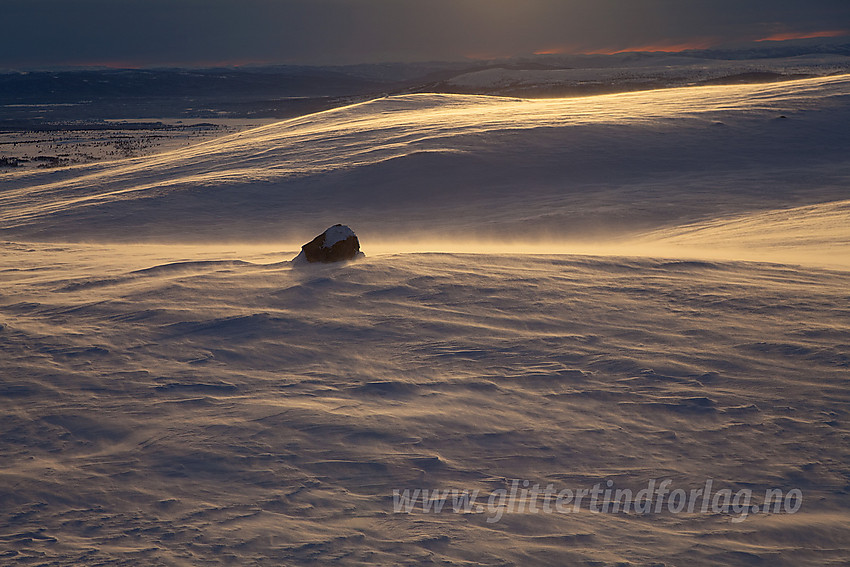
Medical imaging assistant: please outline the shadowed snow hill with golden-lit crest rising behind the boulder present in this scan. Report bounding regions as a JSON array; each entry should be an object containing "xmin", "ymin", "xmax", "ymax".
[{"xmin": 0, "ymin": 75, "xmax": 850, "ymax": 246}]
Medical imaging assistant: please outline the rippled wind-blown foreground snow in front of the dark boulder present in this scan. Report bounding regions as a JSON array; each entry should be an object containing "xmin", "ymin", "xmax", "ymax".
[{"xmin": 0, "ymin": 243, "xmax": 850, "ymax": 565}]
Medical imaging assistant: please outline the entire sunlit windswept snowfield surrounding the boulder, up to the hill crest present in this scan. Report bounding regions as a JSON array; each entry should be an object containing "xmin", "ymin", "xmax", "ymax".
[{"xmin": 0, "ymin": 75, "xmax": 850, "ymax": 566}]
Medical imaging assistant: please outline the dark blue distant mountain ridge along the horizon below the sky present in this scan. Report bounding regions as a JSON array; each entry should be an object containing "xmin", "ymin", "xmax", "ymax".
[{"xmin": 0, "ymin": 41, "xmax": 850, "ymax": 123}]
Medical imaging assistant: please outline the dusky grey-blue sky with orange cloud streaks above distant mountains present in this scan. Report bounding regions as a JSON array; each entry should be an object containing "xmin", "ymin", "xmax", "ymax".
[{"xmin": 0, "ymin": 0, "xmax": 850, "ymax": 69}]
